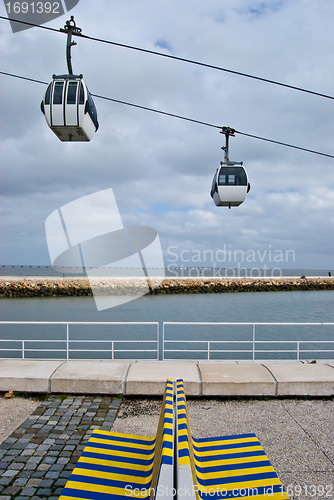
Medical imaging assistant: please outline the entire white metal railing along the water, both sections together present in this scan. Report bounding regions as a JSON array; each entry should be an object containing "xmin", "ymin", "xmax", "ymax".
[{"xmin": 0, "ymin": 321, "xmax": 334, "ymax": 361}]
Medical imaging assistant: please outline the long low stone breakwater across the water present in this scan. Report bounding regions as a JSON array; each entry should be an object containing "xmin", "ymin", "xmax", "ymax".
[{"xmin": 0, "ymin": 277, "xmax": 334, "ymax": 298}]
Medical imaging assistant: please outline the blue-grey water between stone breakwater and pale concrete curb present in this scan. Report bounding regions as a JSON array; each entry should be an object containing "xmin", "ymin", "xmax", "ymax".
[{"xmin": 0, "ymin": 291, "xmax": 334, "ymax": 360}]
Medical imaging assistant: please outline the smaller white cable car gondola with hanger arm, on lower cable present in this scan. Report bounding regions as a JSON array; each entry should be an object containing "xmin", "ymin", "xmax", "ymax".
[{"xmin": 210, "ymin": 127, "xmax": 250, "ymax": 208}]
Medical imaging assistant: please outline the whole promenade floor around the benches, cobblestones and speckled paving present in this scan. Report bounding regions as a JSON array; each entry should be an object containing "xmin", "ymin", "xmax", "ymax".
[{"xmin": 0, "ymin": 372, "xmax": 334, "ymax": 500}]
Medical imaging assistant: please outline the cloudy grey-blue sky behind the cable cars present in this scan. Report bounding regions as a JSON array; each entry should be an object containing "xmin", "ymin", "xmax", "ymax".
[{"xmin": 0, "ymin": 0, "xmax": 334, "ymax": 270}]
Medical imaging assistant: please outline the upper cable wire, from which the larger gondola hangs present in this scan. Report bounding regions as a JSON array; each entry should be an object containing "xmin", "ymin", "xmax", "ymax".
[{"xmin": 0, "ymin": 16, "xmax": 334, "ymax": 100}]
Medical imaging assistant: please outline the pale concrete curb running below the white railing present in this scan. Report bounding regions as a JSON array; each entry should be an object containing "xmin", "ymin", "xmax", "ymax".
[{"xmin": 0, "ymin": 359, "xmax": 334, "ymax": 396}]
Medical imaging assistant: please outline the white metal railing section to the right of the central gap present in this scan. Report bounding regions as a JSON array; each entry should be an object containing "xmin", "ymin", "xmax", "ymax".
[{"xmin": 162, "ymin": 321, "xmax": 334, "ymax": 361}]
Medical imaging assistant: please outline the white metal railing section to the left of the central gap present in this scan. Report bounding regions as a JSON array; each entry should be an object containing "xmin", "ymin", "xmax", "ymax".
[{"xmin": 0, "ymin": 321, "xmax": 159, "ymax": 360}]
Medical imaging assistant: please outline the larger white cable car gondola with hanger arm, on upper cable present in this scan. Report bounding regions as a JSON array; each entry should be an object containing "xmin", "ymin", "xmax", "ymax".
[{"xmin": 41, "ymin": 16, "xmax": 99, "ymax": 141}]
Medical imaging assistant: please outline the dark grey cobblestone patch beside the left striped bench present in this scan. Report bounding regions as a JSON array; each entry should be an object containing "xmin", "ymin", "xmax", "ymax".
[{"xmin": 0, "ymin": 396, "xmax": 121, "ymax": 500}]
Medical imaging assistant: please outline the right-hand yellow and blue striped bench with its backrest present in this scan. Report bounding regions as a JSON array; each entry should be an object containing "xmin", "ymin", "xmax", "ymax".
[{"xmin": 176, "ymin": 380, "xmax": 289, "ymax": 500}]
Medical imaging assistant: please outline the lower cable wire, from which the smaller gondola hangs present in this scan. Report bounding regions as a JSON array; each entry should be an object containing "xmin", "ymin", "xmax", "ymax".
[{"xmin": 0, "ymin": 71, "xmax": 334, "ymax": 158}]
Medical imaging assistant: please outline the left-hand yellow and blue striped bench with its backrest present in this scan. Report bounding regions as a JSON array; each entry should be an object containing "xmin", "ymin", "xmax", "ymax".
[{"xmin": 59, "ymin": 380, "xmax": 174, "ymax": 500}]
